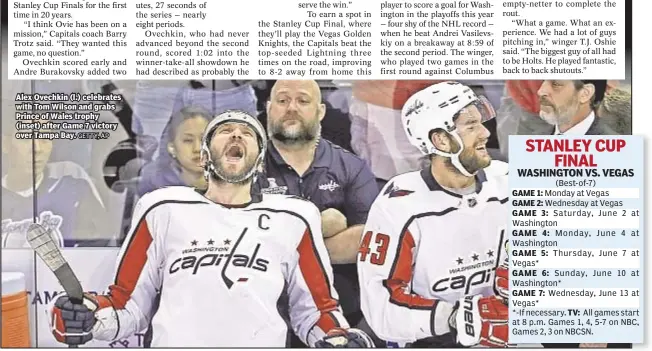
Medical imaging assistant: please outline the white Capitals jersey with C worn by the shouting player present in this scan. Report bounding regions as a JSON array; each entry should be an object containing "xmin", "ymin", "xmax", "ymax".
[{"xmin": 95, "ymin": 187, "xmax": 348, "ymax": 347}]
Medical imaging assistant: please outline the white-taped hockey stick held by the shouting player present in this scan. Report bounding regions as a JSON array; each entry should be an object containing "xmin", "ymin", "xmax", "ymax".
[{"xmin": 26, "ymin": 223, "xmax": 84, "ymax": 348}]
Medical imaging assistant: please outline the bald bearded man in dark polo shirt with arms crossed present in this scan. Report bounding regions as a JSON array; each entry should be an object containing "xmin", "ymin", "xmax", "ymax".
[{"xmin": 256, "ymin": 80, "xmax": 379, "ymax": 347}]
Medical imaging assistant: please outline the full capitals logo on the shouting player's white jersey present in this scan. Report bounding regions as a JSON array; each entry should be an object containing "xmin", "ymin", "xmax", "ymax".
[{"xmin": 169, "ymin": 228, "xmax": 269, "ymax": 289}]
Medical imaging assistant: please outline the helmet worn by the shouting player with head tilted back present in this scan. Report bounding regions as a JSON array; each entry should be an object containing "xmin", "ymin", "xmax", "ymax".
[{"xmin": 201, "ymin": 110, "xmax": 267, "ymax": 182}]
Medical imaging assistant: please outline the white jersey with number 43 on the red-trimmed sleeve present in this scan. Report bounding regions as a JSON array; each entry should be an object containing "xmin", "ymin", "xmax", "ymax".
[{"xmin": 358, "ymin": 165, "xmax": 509, "ymax": 347}]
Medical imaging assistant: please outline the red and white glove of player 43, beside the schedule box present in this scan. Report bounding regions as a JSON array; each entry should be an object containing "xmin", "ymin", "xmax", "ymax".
[{"xmin": 449, "ymin": 295, "xmax": 509, "ymax": 347}]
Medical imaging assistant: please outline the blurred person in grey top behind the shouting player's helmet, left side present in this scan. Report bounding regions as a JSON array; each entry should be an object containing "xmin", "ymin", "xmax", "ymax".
[{"xmin": 138, "ymin": 106, "xmax": 212, "ymax": 196}]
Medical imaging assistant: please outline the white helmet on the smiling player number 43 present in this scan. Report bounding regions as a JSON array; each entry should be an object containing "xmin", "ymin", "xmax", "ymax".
[{"xmin": 401, "ymin": 81, "xmax": 496, "ymax": 177}]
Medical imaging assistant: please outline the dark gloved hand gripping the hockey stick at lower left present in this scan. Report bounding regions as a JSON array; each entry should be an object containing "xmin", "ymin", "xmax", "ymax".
[{"xmin": 47, "ymin": 294, "xmax": 98, "ymax": 345}]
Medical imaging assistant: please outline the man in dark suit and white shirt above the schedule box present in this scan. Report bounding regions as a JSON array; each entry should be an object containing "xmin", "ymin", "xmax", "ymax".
[{"xmin": 538, "ymin": 80, "xmax": 632, "ymax": 348}]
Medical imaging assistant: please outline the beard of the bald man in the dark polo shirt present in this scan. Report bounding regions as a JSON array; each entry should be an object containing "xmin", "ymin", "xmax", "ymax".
[{"xmin": 268, "ymin": 113, "xmax": 321, "ymax": 145}]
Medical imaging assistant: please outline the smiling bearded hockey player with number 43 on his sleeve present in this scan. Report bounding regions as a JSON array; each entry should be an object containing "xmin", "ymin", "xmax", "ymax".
[{"xmin": 358, "ymin": 82, "xmax": 508, "ymax": 347}]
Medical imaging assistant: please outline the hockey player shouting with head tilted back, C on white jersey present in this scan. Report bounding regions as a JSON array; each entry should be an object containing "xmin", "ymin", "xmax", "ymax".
[{"xmin": 50, "ymin": 111, "xmax": 372, "ymax": 347}]
